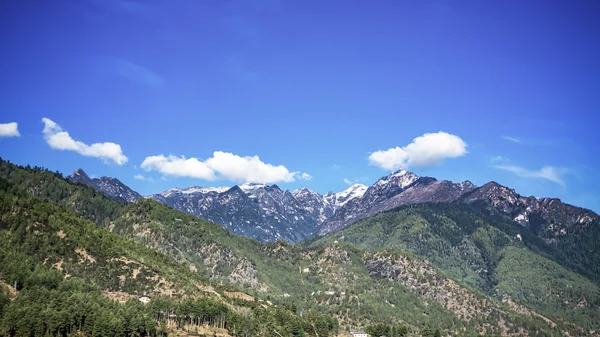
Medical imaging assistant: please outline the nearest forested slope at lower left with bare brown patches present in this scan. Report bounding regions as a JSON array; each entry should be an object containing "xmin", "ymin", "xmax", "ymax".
[{"xmin": 0, "ymin": 160, "xmax": 337, "ymax": 336}]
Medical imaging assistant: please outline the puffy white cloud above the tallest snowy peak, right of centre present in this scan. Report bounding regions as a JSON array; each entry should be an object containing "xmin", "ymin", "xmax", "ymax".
[{"xmin": 369, "ymin": 131, "xmax": 467, "ymax": 171}]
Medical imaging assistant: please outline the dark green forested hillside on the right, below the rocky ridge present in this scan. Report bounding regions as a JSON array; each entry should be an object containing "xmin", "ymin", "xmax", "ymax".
[{"xmin": 304, "ymin": 203, "xmax": 600, "ymax": 330}]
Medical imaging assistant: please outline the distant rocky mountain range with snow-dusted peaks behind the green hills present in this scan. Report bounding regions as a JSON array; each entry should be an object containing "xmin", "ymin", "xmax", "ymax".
[{"xmin": 67, "ymin": 169, "xmax": 598, "ymax": 248}]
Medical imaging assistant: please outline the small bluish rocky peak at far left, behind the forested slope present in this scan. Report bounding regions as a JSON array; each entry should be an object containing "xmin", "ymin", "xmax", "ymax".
[{"xmin": 67, "ymin": 169, "xmax": 142, "ymax": 202}]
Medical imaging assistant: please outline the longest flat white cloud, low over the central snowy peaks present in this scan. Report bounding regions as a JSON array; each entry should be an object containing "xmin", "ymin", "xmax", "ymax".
[{"xmin": 141, "ymin": 151, "xmax": 312, "ymax": 184}]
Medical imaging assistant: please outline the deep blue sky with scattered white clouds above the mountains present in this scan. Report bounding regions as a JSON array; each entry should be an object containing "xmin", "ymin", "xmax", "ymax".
[{"xmin": 0, "ymin": 0, "xmax": 600, "ymax": 211}]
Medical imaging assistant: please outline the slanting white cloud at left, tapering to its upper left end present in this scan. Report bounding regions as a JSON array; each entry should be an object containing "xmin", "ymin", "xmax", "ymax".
[{"xmin": 42, "ymin": 118, "xmax": 127, "ymax": 166}]
